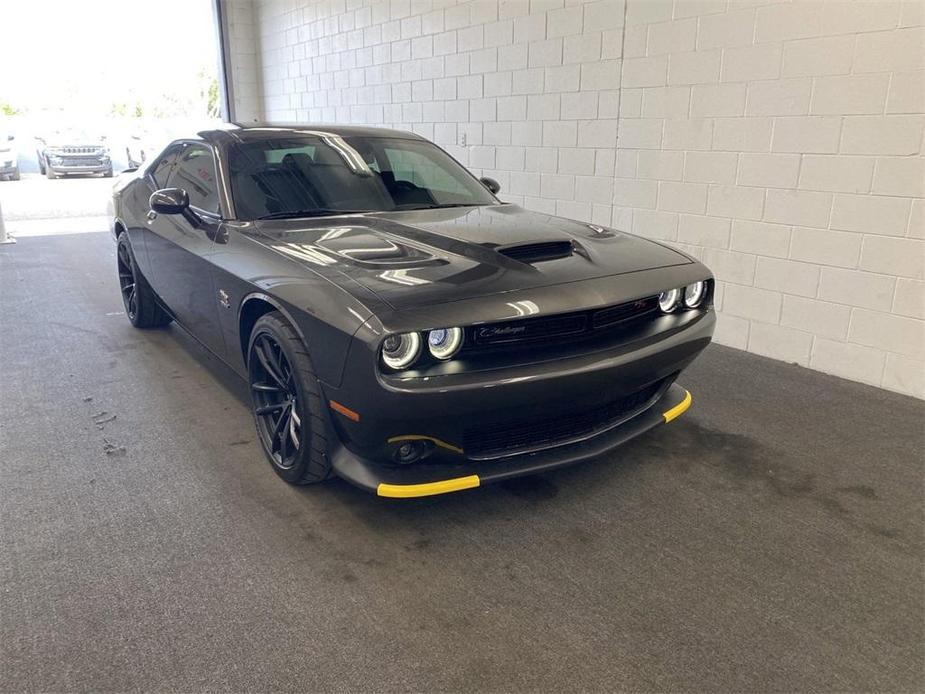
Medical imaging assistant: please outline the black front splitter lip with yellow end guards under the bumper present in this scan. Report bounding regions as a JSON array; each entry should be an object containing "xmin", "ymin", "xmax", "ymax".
[{"xmin": 332, "ymin": 384, "xmax": 691, "ymax": 498}]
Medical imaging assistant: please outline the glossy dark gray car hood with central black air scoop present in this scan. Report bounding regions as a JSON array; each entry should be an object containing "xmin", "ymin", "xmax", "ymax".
[{"xmin": 256, "ymin": 204, "xmax": 691, "ymax": 310}]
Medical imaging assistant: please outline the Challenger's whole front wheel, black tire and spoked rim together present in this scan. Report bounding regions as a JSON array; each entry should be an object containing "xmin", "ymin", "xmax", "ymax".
[{"xmin": 247, "ymin": 311, "xmax": 331, "ymax": 485}]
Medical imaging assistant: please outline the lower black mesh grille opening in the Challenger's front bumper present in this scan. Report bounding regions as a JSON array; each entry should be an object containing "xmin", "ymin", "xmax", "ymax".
[{"xmin": 463, "ymin": 381, "xmax": 664, "ymax": 460}]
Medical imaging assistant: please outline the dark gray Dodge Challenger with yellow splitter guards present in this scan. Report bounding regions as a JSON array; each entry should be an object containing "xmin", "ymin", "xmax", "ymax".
[{"xmin": 113, "ymin": 126, "xmax": 715, "ymax": 497}]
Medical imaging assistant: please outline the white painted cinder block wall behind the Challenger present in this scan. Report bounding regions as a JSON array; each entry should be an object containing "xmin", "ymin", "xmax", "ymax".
[{"xmin": 227, "ymin": 0, "xmax": 925, "ymax": 397}]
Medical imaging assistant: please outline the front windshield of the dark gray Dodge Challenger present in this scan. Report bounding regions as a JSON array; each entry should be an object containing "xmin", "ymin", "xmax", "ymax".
[{"xmin": 229, "ymin": 133, "xmax": 496, "ymax": 219}]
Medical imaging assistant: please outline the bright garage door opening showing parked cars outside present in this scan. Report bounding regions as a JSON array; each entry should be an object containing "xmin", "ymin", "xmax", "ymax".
[{"xmin": 0, "ymin": 0, "xmax": 222, "ymax": 237}]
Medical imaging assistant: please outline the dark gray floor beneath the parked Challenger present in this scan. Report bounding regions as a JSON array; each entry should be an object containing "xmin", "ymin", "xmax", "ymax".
[{"xmin": 0, "ymin": 233, "xmax": 925, "ymax": 691}]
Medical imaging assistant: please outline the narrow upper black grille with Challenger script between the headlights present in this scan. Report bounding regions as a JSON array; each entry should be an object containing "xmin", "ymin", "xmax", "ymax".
[{"xmin": 466, "ymin": 296, "xmax": 658, "ymax": 349}]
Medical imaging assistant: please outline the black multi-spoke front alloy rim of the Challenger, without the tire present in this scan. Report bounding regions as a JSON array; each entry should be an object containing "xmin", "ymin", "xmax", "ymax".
[{"xmin": 249, "ymin": 332, "xmax": 303, "ymax": 470}]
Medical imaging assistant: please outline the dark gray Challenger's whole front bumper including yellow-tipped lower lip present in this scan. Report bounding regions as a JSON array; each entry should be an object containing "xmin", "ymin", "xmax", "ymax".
[{"xmin": 323, "ymin": 310, "xmax": 715, "ymax": 496}]
